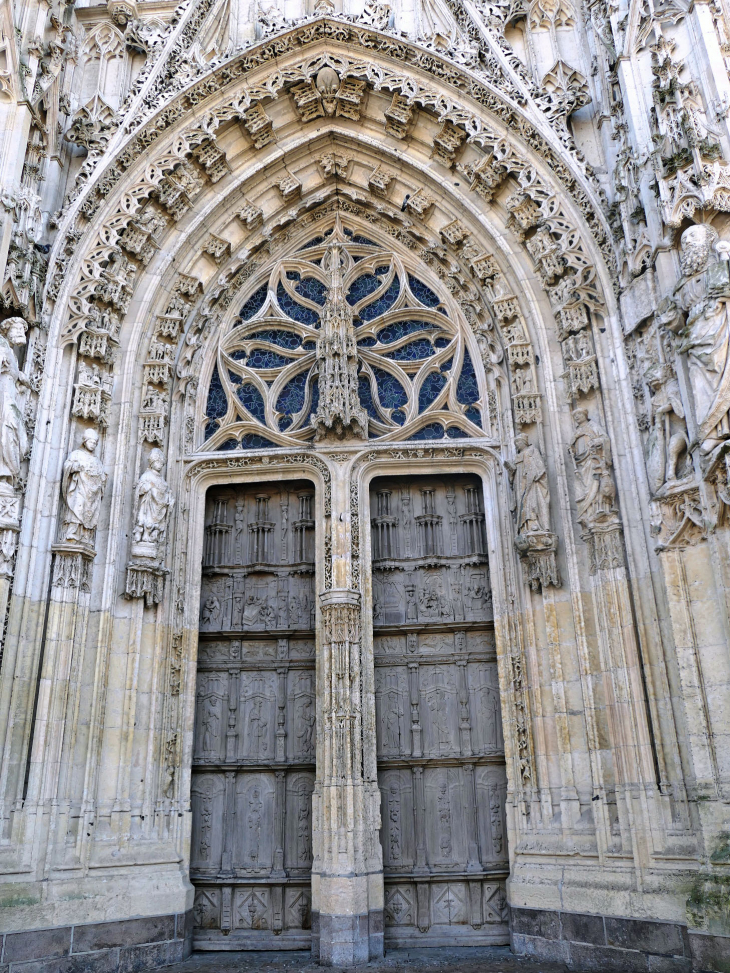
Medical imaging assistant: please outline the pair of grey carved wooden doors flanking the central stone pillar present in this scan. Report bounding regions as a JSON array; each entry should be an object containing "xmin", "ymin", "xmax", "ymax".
[{"xmin": 190, "ymin": 476, "xmax": 508, "ymax": 949}]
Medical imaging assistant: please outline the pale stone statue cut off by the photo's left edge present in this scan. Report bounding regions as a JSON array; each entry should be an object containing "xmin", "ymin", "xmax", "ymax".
[{"xmin": 0, "ymin": 317, "xmax": 30, "ymax": 494}]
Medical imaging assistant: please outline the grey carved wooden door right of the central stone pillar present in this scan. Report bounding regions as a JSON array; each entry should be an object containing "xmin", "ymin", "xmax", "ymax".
[{"xmin": 370, "ymin": 476, "xmax": 509, "ymax": 945}]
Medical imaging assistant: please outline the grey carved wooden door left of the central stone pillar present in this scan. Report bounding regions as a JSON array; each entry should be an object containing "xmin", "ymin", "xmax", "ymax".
[{"xmin": 190, "ymin": 483, "xmax": 315, "ymax": 949}]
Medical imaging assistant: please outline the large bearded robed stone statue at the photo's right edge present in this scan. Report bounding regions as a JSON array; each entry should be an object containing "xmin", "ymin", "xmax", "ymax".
[{"xmin": 666, "ymin": 223, "xmax": 730, "ymax": 453}]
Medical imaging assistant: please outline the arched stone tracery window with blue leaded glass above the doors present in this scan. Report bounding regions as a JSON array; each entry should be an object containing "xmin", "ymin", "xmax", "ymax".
[{"xmin": 204, "ymin": 223, "xmax": 486, "ymax": 450}]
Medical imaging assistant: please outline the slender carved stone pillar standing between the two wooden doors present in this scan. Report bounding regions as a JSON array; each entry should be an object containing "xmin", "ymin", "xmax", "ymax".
[{"xmin": 312, "ymin": 457, "xmax": 383, "ymax": 966}]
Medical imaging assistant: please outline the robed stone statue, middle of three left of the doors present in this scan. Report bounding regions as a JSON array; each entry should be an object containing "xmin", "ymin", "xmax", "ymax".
[{"xmin": 61, "ymin": 429, "xmax": 107, "ymax": 545}]
